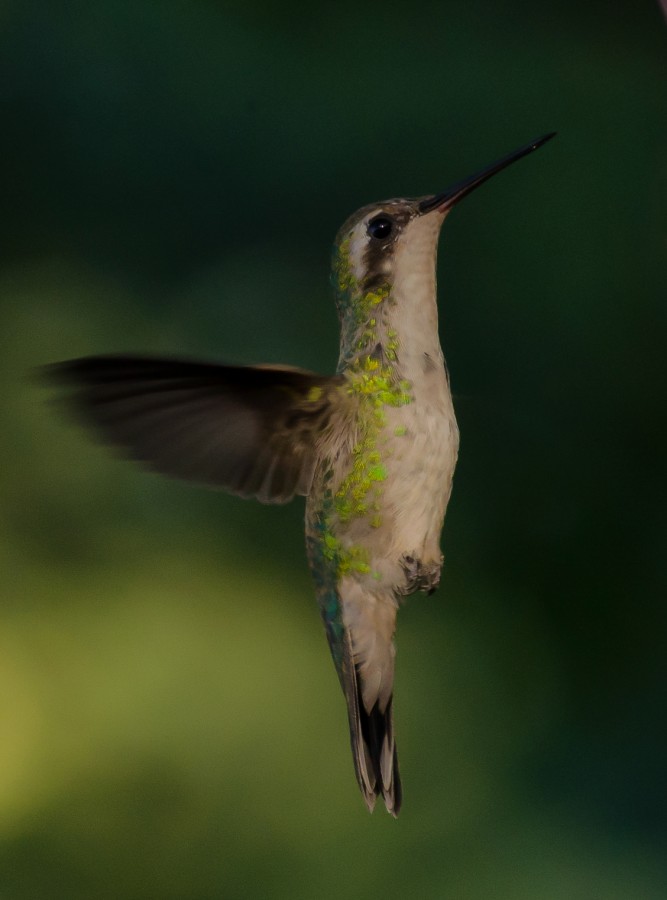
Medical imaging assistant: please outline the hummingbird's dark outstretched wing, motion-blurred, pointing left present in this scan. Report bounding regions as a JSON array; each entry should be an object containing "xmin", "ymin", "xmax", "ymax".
[{"xmin": 44, "ymin": 356, "xmax": 341, "ymax": 503}]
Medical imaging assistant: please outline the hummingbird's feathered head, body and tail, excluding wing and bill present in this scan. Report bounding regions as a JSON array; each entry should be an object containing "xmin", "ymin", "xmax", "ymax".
[{"xmin": 306, "ymin": 200, "xmax": 458, "ymax": 814}]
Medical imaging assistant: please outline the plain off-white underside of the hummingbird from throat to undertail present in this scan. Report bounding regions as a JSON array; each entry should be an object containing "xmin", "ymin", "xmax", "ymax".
[{"xmin": 328, "ymin": 207, "xmax": 459, "ymax": 711}]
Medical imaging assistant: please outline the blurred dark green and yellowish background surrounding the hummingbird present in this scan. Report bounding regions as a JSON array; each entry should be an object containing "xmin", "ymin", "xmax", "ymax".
[{"xmin": 0, "ymin": 0, "xmax": 667, "ymax": 900}]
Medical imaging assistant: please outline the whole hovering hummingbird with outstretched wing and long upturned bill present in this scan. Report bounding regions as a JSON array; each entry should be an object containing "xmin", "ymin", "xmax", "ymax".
[{"xmin": 46, "ymin": 133, "xmax": 554, "ymax": 816}]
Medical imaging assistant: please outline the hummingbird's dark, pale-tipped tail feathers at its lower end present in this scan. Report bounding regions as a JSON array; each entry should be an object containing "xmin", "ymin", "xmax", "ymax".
[{"xmin": 344, "ymin": 666, "xmax": 403, "ymax": 817}]
